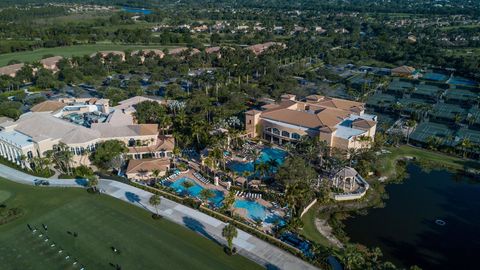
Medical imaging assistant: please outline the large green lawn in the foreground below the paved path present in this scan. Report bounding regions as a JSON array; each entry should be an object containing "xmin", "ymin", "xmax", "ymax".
[{"xmin": 0, "ymin": 179, "xmax": 261, "ymax": 270}]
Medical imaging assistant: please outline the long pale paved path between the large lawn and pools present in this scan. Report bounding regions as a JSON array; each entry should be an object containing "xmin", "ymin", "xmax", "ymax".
[{"xmin": 0, "ymin": 164, "xmax": 316, "ymax": 270}]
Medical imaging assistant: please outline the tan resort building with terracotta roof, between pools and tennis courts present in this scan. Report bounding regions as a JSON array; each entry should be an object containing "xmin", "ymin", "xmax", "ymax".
[{"xmin": 245, "ymin": 95, "xmax": 377, "ymax": 150}]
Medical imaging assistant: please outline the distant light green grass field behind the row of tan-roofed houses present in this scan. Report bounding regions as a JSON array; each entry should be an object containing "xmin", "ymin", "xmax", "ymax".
[{"xmin": 0, "ymin": 43, "xmax": 177, "ymax": 66}]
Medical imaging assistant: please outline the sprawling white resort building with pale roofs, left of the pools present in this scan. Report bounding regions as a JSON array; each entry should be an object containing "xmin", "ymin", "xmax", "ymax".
[{"xmin": 0, "ymin": 98, "xmax": 163, "ymax": 168}]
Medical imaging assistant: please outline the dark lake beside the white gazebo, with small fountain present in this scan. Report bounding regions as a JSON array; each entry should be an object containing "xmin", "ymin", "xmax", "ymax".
[{"xmin": 344, "ymin": 164, "xmax": 480, "ymax": 269}]
